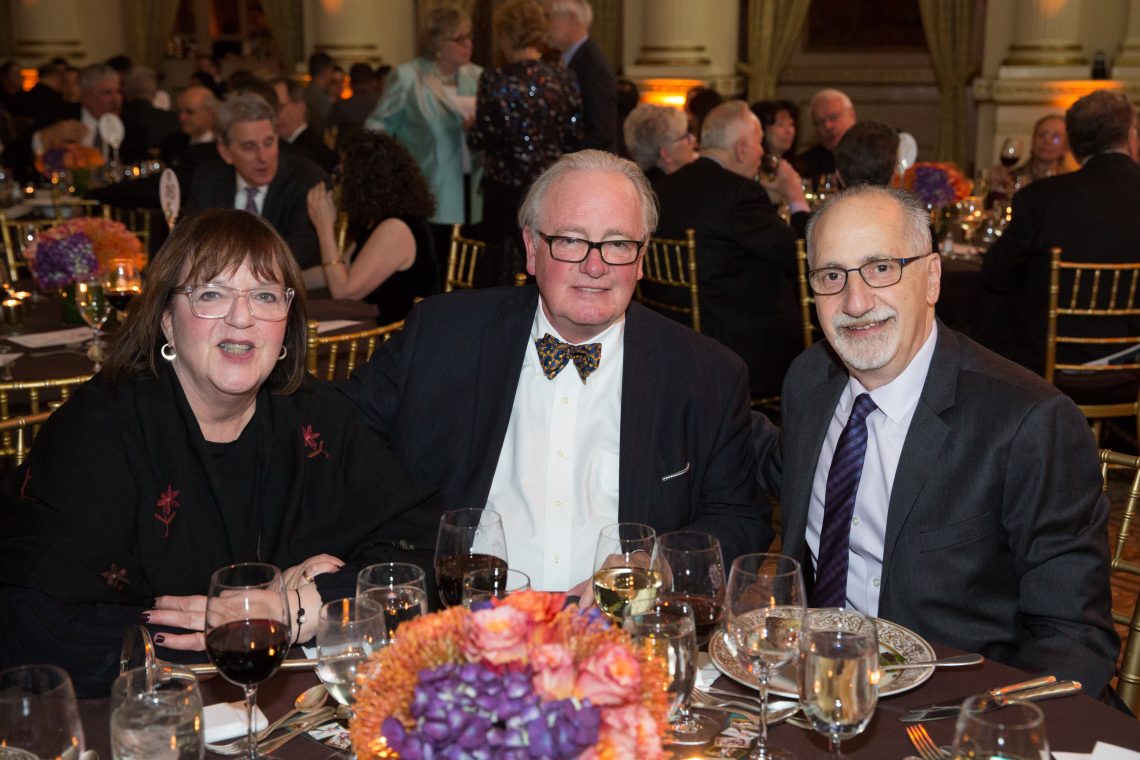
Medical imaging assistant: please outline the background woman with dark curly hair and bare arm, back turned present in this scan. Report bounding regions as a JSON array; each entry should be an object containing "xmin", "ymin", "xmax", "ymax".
[{"xmin": 308, "ymin": 132, "xmax": 435, "ymax": 325}]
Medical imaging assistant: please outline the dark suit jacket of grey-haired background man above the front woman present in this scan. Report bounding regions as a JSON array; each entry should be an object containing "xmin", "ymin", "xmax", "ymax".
[{"xmin": 187, "ymin": 150, "xmax": 328, "ymax": 269}]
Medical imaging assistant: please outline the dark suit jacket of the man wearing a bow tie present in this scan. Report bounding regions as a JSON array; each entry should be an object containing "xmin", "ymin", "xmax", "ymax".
[{"xmin": 343, "ymin": 287, "xmax": 773, "ymax": 569}]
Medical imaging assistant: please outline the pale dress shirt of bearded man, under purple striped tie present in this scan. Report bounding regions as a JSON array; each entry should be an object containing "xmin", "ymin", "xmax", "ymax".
[{"xmin": 807, "ymin": 325, "xmax": 938, "ymax": 615}]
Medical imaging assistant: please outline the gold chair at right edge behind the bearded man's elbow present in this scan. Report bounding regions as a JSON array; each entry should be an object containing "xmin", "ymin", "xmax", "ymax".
[{"xmin": 1100, "ymin": 449, "xmax": 1140, "ymax": 714}]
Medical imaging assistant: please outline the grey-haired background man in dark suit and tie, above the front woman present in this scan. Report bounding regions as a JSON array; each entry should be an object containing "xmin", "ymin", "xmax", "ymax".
[{"xmin": 187, "ymin": 93, "xmax": 328, "ymax": 269}]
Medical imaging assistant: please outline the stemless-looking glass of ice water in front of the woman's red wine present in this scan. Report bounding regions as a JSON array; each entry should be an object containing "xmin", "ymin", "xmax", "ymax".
[{"xmin": 111, "ymin": 664, "xmax": 205, "ymax": 760}]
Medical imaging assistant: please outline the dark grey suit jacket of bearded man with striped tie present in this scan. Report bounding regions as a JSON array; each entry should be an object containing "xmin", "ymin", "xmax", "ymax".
[{"xmin": 757, "ymin": 324, "xmax": 1119, "ymax": 695}]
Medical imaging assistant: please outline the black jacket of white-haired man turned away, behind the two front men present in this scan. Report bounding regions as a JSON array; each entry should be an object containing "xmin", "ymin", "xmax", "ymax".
[{"xmin": 657, "ymin": 158, "xmax": 803, "ymax": 395}]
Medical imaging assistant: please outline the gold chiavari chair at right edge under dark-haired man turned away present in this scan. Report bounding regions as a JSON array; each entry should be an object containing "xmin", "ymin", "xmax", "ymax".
[{"xmin": 1044, "ymin": 247, "xmax": 1140, "ymax": 441}]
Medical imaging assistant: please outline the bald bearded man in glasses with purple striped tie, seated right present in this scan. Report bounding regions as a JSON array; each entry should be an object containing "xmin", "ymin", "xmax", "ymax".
[{"xmin": 756, "ymin": 185, "xmax": 1119, "ymax": 695}]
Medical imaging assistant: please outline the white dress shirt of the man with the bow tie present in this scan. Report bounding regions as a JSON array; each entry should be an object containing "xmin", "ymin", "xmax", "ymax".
[{"xmin": 487, "ymin": 297, "xmax": 625, "ymax": 591}]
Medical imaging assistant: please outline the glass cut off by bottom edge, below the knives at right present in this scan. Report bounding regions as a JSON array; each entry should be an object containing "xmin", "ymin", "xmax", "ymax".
[{"xmin": 950, "ymin": 696, "xmax": 1049, "ymax": 760}]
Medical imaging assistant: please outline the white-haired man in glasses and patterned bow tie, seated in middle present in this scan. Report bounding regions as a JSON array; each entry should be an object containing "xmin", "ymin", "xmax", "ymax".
[{"xmin": 335, "ymin": 150, "xmax": 772, "ymax": 591}]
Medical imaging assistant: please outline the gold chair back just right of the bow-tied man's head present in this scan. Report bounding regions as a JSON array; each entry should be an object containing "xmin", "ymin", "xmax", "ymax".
[{"xmin": 634, "ymin": 229, "xmax": 701, "ymax": 333}]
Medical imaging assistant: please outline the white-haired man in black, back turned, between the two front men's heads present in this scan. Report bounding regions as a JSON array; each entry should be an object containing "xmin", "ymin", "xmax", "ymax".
[{"xmin": 657, "ymin": 100, "xmax": 807, "ymax": 397}]
